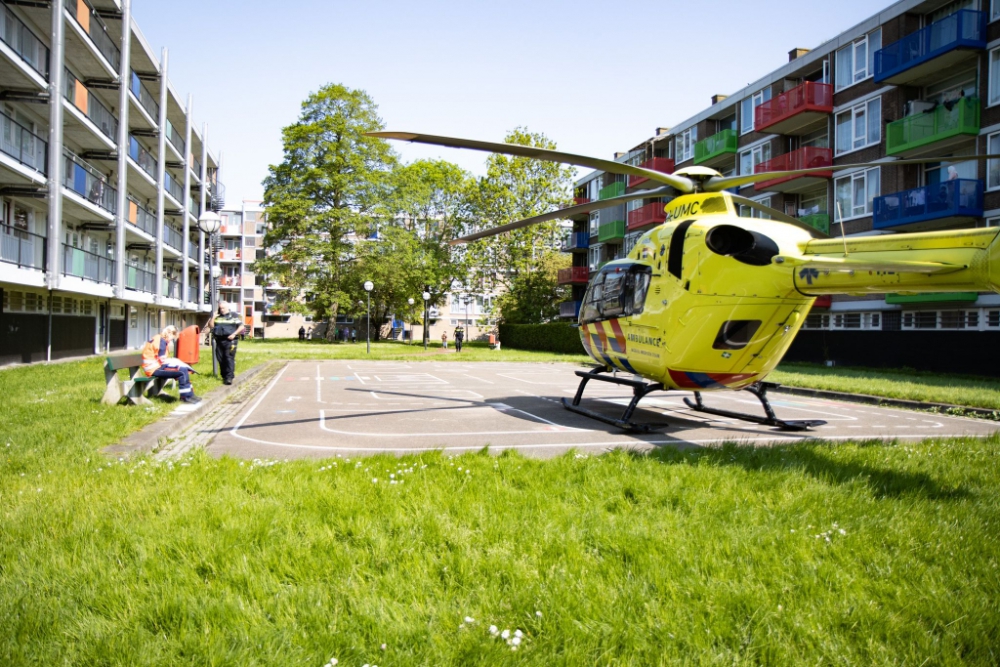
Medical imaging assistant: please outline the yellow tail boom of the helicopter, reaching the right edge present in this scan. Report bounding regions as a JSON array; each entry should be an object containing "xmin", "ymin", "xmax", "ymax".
[{"xmin": 788, "ymin": 228, "xmax": 1000, "ymax": 296}]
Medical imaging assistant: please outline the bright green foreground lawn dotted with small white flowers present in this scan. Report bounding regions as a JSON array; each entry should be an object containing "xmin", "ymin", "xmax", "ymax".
[{"xmin": 0, "ymin": 343, "xmax": 1000, "ymax": 667}]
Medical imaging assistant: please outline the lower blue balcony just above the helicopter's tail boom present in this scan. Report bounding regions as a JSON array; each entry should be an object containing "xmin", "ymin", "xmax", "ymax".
[{"xmin": 872, "ymin": 179, "xmax": 983, "ymax": 231}]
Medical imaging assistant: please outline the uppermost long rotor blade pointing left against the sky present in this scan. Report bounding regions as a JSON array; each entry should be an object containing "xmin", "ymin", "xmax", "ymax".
[{"xmin": 365, "ymin": 132, "xmax": 695, "ymax": 193}]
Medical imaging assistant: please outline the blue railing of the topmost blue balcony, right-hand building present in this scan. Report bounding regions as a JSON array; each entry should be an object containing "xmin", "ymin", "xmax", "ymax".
[{"xmin": 875, "ymin": 9, "xmax": 986, "ymax": 83}]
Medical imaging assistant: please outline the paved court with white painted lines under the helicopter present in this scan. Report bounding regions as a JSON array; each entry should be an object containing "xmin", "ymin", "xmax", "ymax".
[{"xmin": 191, "ymin": 361, "xmax": 1000, "ymax": 458}]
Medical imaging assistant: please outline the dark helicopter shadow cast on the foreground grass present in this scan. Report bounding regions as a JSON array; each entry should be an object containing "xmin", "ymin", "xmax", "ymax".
[{"xmin": 629, "ymin": 440, "xmax": 972, "ymax": 500}]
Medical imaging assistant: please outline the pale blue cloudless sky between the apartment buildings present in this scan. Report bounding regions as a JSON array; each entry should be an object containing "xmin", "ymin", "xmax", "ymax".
[{"xmin": 132, "ymin": 0, "xmax": 889, "ymax": 206}]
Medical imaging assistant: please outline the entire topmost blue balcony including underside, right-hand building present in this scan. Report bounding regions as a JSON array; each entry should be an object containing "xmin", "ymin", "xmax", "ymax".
[{"xmin": 875, "ymin": 9, "xmax": 986, "ymax": 86}]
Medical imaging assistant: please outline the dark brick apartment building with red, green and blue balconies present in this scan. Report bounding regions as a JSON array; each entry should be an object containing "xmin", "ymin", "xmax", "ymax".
[{"xmin": 560, "ymin": 0, "xmax": 1000, "ymax": 372}]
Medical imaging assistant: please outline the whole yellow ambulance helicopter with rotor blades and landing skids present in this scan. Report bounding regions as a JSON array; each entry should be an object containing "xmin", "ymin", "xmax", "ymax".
[{"xmin": 370, "ymin": 132, "xmax": 1000, "ymax": 430}]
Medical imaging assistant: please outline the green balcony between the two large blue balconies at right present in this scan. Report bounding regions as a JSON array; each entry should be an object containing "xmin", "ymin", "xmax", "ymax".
[{"xmin": 885, "ymin": 97, "xmax": 979, "ymax": 157}]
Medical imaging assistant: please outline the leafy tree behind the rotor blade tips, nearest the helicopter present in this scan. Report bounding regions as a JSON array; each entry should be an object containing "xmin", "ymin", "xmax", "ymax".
[{"xmin": 468, "ymin": 128, "xmax": 575, "ymax": 323}]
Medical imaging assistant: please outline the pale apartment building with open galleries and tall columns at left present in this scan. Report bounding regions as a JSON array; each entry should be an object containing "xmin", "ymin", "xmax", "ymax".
[{"xmin": 0, "ymin": 0, "xmax": 224, "ymax": 364}]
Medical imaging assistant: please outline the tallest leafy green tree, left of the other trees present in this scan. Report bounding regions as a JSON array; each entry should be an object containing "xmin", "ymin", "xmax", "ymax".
[{"xmin": 255, "ymin": 84, "xmax": 398, "ymax": 340}]
